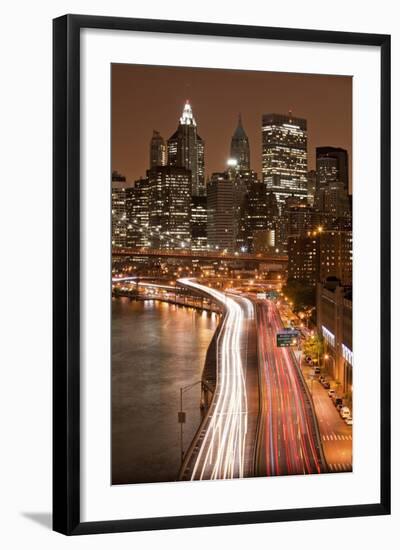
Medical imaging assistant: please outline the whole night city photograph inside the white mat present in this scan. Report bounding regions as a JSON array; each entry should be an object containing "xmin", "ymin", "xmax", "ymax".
[{"xmin": 110, "ymin": 65, "xmax": 353, "ymax": 485}]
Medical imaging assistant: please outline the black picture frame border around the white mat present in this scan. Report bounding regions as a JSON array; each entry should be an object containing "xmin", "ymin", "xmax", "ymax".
[{"xmin": 53, "ymin": 15, "xmax": 390, "ymax": 535}]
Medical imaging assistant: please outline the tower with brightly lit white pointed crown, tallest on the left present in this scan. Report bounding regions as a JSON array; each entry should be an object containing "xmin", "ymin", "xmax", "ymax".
[{"xmin": 168, "ymin": 100, "xmax": 205, "ymax": 196}]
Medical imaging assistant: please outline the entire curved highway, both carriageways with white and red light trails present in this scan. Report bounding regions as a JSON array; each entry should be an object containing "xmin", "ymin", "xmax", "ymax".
[{"xmin": 178, "ymin": 278, "xmax": 327, "ymax": 480}]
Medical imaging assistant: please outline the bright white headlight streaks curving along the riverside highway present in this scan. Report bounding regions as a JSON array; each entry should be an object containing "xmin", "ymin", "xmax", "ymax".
[{"xmin": 178, "ymin": 279, "xmax": 254, "ymax": 480}]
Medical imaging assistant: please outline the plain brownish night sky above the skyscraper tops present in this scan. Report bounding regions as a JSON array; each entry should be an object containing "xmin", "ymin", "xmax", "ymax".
[{"xmin": 112, "ymin": 64, "xmax": 352, "ymax": 190}]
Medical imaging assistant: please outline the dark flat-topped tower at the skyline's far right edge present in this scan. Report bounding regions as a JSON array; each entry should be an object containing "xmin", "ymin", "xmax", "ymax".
[{"xmin": 315, "ymin": 147, "xmax": 349, "ymax": 193}]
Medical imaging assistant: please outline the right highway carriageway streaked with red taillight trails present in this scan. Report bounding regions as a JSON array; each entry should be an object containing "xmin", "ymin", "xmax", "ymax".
[{"xmin": 256, "ymin": 300, "xmax": 326, "ymax": 476}]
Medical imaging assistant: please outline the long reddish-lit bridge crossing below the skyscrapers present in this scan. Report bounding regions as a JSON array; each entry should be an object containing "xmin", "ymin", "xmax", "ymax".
[{"xmin": 112, "ymin": 247, "xmax": 288, "ymax": 266}]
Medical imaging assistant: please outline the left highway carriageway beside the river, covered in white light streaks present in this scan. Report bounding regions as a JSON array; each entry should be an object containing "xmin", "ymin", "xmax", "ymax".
[{"xmin": 178, "ymin": 279, "xmax": 259, "ymax": 480}]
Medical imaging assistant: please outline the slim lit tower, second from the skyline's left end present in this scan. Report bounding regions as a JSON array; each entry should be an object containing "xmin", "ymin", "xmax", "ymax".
[{"xmin": 126, "ymin": 178, "xmax": 149, "ymax": 247}]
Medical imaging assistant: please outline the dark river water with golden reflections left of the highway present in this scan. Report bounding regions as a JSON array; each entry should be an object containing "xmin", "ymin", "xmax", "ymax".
[{"xmin": 112, "ymin": 298, "xmax": 217, "ymax": 484}]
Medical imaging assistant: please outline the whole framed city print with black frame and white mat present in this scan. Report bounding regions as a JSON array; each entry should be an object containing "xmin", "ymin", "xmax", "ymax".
[{"xmin": 53, "ymin": 15, "xmax": 390, "ymax": 535}]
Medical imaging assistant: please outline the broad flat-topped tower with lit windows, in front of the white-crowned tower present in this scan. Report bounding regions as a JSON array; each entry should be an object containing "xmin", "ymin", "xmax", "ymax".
[{"xmin": 147, "ymin": 166, "xmax": 192, "ymax": 248}]
